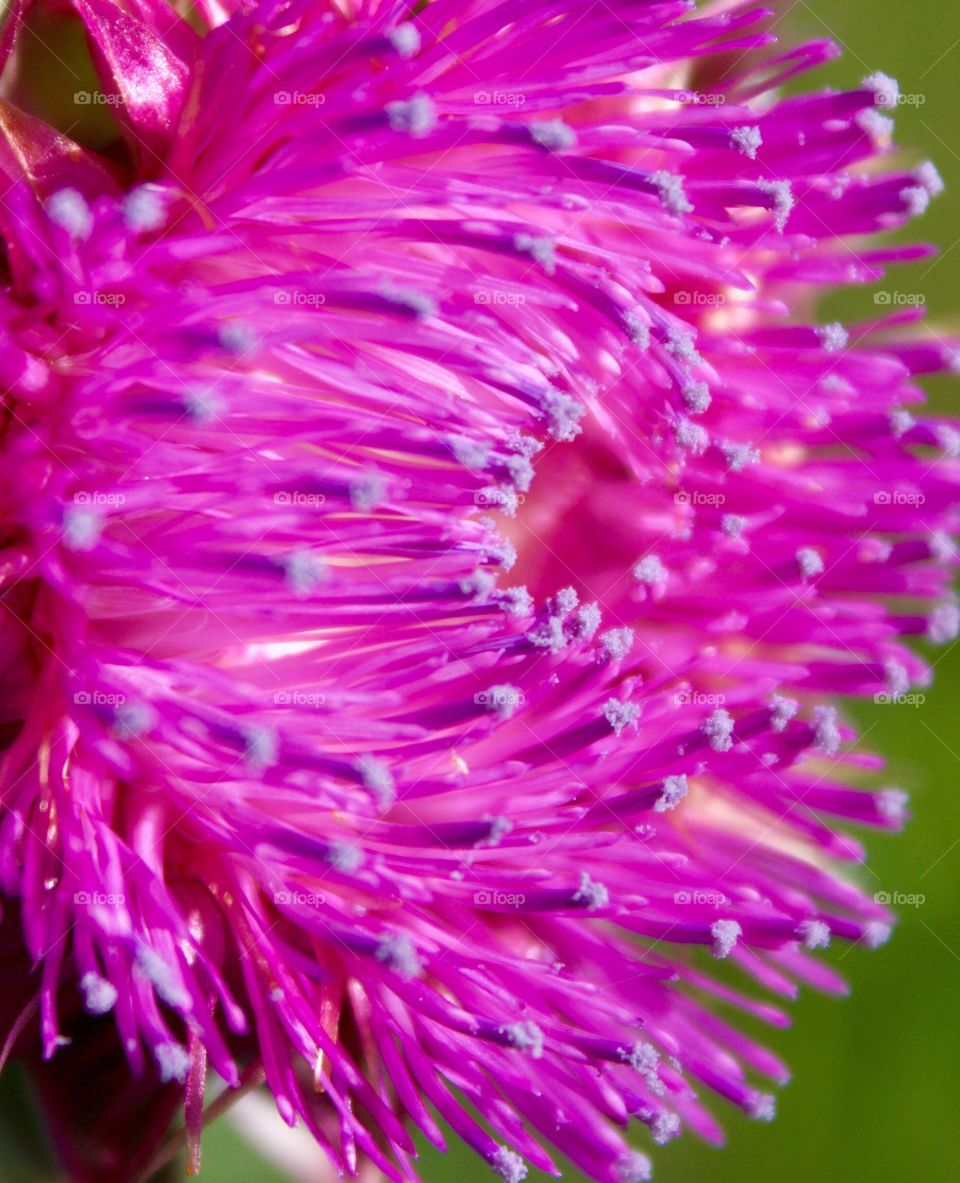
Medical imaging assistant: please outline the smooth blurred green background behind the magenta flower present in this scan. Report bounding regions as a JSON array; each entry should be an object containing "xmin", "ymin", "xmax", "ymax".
[{"xmin": 7, "ymin": 0, "xmax": 960, "ymax": 1183}]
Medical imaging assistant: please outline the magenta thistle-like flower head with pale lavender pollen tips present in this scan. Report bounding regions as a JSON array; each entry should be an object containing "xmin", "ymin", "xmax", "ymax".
[{"xmin": 0, "ymin": 0, "xmax": 960, "ymax": 1183}]
